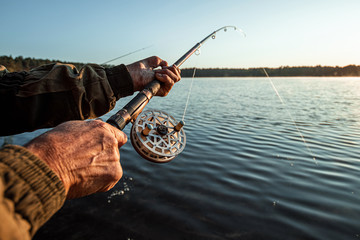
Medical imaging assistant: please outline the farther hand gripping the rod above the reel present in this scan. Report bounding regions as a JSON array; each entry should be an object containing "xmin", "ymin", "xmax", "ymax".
[{"xmin": 126, "ymin": 56, "xmax": 181, "ymax": 96}]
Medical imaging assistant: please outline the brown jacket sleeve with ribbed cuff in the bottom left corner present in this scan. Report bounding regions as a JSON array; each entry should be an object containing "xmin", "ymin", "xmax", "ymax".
[{"xmin": 0, "ymin": 145, "xmax": 66, "ymax": 240}]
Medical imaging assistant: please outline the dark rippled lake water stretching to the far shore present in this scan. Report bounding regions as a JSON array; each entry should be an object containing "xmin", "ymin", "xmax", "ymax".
[{"xmin": 3, "ymin": 77, "xmax": 360, "ymax": 240}]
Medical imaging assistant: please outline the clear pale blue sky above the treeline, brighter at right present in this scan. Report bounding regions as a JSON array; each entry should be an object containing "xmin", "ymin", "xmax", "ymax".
[{"xmin": 0, "ymin": 0, "xmax": 360, "ymax": 68}]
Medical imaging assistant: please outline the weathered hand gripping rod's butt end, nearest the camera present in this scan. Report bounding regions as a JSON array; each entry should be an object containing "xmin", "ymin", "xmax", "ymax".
[{"xmin": 25, "ymin": 120, "xmax": 127, "ymax": 199}]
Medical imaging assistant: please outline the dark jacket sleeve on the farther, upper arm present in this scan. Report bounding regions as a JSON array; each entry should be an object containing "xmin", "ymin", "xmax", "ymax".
[{"xmin": 0, "ymin": 63, "xmax": 133, "ymax": 136}]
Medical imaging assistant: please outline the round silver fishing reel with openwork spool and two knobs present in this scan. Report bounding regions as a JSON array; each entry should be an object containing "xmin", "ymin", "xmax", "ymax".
[{"xmin": 130, "ymin": 109, "xmax": 186, "ymax": 163}]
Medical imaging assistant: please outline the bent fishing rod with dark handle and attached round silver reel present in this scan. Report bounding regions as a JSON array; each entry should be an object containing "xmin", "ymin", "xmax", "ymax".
[{"xmin": 107, "ymin": 26, "xmax": 242, "ymax": 163}]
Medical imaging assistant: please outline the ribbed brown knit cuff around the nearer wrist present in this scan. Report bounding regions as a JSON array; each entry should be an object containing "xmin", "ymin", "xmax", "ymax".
[{"xmin": 0, "ymin": 145, "xmax": 66, "ymax": 235}]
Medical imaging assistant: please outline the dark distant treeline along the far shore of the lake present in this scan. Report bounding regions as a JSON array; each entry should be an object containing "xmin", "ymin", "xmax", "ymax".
[{"xmin": 0, "ymin": 56, "xmax": 360, "ymax": 77}]
